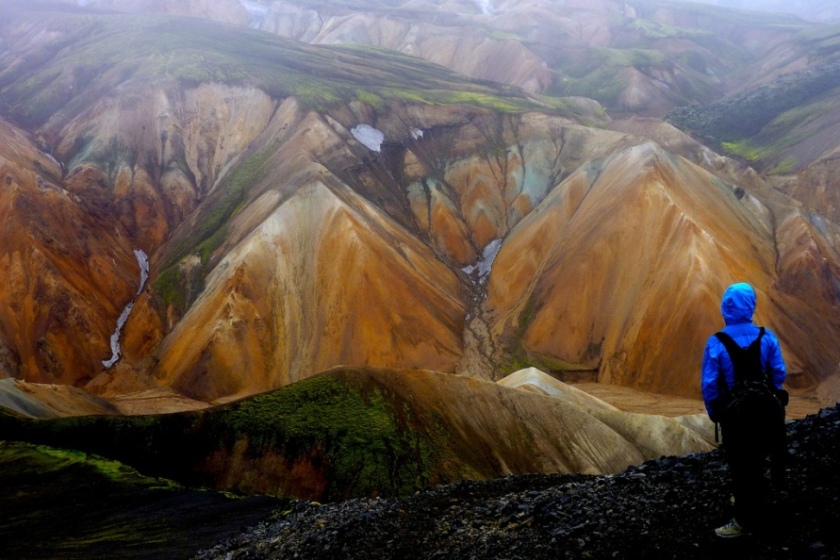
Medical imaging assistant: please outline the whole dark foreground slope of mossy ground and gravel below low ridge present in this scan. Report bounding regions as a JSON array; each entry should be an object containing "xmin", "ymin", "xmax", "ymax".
[{"xmin": 0, "ymin": 409, "xmax": 840, "ymax": 560}]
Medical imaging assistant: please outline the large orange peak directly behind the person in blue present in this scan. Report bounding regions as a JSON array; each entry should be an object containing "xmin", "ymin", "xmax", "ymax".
[{"xmin": 489, "ymin": 144, "xmax": 837, "ymax": 396}]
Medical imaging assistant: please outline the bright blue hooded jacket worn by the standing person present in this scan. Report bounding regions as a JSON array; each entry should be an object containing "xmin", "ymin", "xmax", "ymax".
[{"xmin": 701, "ymin": 283, "xmax": 787, "ymax": 416}]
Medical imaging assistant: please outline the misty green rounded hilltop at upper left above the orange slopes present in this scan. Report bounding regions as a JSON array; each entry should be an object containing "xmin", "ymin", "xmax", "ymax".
[{"xmin": 0, "ymin": 0, "xmax": 564, "ymax": 128}]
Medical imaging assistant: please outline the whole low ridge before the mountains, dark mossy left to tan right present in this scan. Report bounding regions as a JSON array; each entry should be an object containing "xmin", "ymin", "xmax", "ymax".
[{"xmin": 0, "ymin": 369, "xmax": 713, "ymax": 500}]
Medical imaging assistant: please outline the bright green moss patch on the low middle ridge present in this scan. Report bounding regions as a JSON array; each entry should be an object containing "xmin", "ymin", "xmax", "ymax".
[{"xmin": 212, "ymin": 375, "xmax": 441, "ymax": 499}]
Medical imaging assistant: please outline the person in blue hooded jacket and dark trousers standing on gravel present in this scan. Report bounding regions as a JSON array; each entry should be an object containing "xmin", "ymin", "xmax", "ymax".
[{"xmin": 701, "ymin": 283, "xmax": 787, "ymax": 537}]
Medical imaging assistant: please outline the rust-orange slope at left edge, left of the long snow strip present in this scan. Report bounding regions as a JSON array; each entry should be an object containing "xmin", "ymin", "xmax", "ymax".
[{"xmin": 0, "ymin": 121, "xmax": 140, "ymax": 385}]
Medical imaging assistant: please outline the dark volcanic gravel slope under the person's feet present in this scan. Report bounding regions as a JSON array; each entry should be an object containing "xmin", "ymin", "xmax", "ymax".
[{"xmin": 196, "ymin": 407, "xmax": 840, "ymax": 560}]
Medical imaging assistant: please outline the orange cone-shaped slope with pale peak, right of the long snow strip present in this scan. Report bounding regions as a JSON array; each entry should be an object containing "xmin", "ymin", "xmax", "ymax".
[{"xmin": 156, "ymin": 177, "xmax": 465, "ymax": 400}]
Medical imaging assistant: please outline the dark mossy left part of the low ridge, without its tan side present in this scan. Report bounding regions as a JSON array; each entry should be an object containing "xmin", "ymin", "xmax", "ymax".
[{"xmin": 0, "ymin": 374, "xmax": 460, "ymax": 500}]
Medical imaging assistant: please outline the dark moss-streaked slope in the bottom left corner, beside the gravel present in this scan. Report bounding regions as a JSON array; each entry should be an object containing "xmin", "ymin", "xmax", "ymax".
[{"xmin": 0, "ymin": 441, "xmax": 285, "ymax": 560}]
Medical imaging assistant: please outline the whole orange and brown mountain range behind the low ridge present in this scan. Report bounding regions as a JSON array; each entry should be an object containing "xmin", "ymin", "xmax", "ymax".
[{"xmin": 0, "ymin": 2, "xmax": 840, "ymax": 402}]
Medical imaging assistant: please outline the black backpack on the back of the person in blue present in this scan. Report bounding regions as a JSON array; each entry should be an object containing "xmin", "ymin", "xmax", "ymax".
[{"xmin": 715, "ymin": 327, "xmax": 786, "ymax": 453}]
